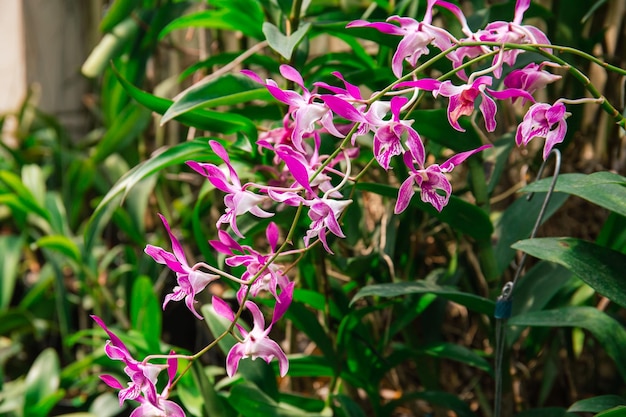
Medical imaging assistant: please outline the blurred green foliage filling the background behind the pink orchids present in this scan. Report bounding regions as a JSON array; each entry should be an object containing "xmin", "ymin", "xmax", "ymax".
[{"xmin": 0, "ymin": 0, "xmax": 626, "ymax": 417}]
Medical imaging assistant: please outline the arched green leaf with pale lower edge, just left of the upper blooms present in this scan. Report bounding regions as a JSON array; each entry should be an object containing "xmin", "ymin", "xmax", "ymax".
[{"xmin": 161, "ymin": 74, "xmax": 272, "ymax": 124}]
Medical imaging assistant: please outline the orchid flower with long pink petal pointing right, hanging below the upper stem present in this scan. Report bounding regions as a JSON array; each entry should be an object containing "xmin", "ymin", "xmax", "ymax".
[{"xmin": 394, "ymin": 145, "xmax": 492, "ymax": 214}]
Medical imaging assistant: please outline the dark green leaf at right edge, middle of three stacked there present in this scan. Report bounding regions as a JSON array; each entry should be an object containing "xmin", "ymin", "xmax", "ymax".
[{"xmin": 513, "ymin": 238, "xmax": 626, "ymax": 308}]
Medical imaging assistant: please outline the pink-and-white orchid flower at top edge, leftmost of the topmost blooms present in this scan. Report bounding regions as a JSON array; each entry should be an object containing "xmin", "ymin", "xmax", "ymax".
[{"xmin": 346, "ymin": 0, "xmax": 454, "ymax": 78}]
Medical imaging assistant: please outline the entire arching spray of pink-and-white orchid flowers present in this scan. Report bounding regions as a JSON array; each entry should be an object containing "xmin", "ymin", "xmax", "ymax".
[{"xmin": 94, "ymin": 0, "xmax": 604, "ymax": 416}]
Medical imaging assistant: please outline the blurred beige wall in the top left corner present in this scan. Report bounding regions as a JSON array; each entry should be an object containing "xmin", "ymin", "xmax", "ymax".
[{"xmin": 0, "ymin": 0, "xmax": 91, "ymax": 134}]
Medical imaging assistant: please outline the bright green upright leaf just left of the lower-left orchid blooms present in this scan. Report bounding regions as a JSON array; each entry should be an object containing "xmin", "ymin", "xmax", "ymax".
[{"xmin": 130, "ymin": 276, "xmax": 161, "ymax": 352}]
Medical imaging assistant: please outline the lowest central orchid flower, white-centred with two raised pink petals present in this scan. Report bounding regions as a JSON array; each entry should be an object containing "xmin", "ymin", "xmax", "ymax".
[{"xmin": 213, "ymin": 288, "xmax": 294, "ymax": 377}]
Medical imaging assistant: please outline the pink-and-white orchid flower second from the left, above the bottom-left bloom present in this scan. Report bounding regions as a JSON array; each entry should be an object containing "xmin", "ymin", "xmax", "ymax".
[{"xmin": 144, "ymin": 214, "xmax": 219, "ymax": 320}]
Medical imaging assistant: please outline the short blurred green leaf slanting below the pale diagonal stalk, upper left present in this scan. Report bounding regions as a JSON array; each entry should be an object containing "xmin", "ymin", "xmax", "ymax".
[{"xmin": 92, "ymin": 102, "xmax": 152, "ymax": 164}]
